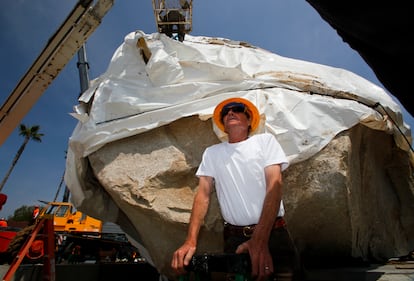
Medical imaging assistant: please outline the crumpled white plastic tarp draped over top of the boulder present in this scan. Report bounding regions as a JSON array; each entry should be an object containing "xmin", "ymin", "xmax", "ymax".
[{"xmin": 65, "ymin": 31, "xmax": 411, "ymax": 208}]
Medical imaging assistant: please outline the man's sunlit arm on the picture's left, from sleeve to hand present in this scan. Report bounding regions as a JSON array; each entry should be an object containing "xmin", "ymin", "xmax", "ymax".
[{"xmin": 171, "ymin": 176, "xmax": 214, "ymax": 274}]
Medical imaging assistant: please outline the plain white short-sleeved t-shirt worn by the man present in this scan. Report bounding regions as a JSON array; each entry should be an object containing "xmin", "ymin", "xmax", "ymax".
[{"xmin": 196, "ymin": 133, "xmax": 289, "ymax": 225}]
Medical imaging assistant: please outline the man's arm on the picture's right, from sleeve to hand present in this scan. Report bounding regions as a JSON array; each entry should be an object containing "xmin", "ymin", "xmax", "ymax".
[{"xmin": 236, "ymin": 165, "xmax": 282, "ymax": 280}]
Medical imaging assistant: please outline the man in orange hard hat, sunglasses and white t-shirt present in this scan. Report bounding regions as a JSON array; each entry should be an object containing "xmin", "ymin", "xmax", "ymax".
[{"xmin": 171, "ymin": 98, "xmax": 299, "ymax": 280}]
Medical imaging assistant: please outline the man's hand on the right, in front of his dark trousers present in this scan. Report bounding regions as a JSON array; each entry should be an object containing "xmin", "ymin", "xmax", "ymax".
[{"xmin": 236, "ymin": 239, "xmax": 273, "ymax": 281}]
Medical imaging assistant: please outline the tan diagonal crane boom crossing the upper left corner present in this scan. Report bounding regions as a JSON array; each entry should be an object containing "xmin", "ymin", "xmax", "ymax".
[{"xmin": 0, "ymin": 0, "xmax": 114, "ymax": 145}]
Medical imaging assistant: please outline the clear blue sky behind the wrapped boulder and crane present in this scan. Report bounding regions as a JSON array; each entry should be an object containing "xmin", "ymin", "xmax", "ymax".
[{"xmin": 0, "ymin": 0, "xmax": 414, "ymax": 217}]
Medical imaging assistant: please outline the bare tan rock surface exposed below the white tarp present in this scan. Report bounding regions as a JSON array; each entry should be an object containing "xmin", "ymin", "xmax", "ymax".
[{"xmin": 83, "ymin": 116, "xmax": 414, "ymax": 277}]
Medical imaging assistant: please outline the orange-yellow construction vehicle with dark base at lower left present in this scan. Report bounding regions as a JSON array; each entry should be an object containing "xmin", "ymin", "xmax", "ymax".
[{"xmin": 34, "ymin": 202, "xmax": 144, "ymax": 263}]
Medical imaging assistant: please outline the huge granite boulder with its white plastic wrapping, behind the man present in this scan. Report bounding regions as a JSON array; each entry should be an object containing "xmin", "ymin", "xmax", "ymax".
[{"xmin": 65, "ymin": 31, "xmax": 414, "ymax": 278}]
